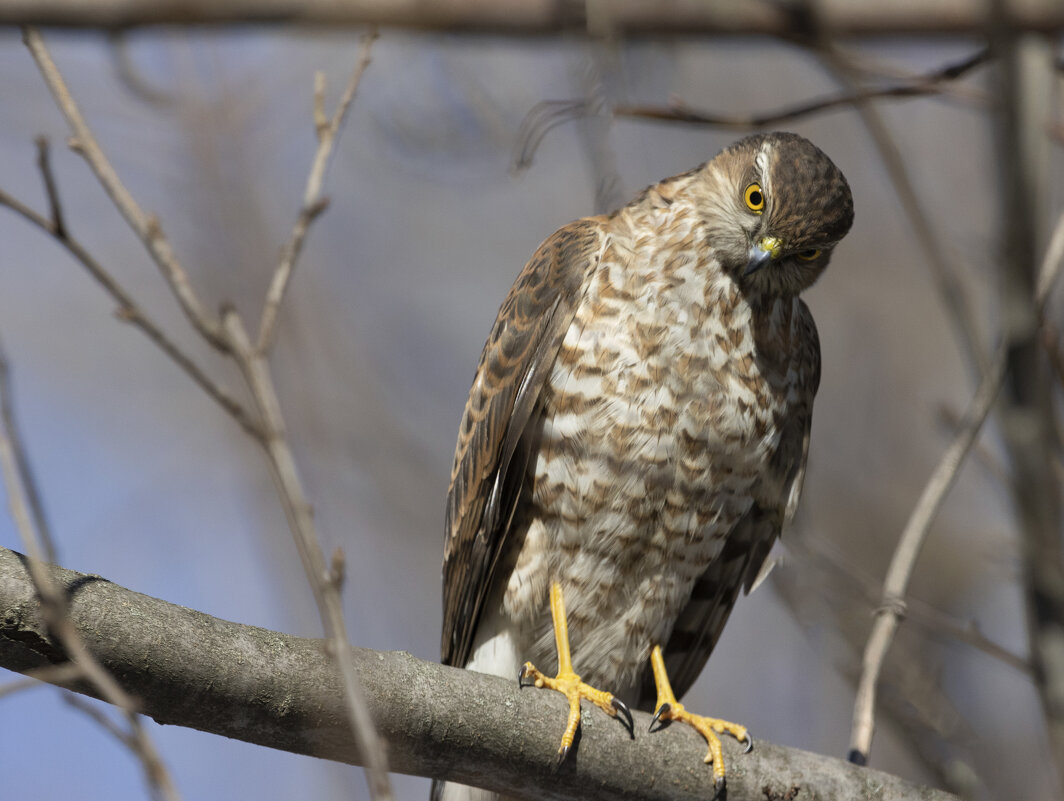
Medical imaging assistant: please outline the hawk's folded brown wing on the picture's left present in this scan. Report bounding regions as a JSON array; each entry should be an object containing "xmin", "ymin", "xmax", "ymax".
[{"xmin": 440, "ymin": 218, "xmax": 602, "ymax": 666}]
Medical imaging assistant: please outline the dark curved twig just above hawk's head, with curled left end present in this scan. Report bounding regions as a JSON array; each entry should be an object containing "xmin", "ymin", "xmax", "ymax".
[{"xmin": 514, "ymin": 50, "xmax": 990, "ymax": 170}]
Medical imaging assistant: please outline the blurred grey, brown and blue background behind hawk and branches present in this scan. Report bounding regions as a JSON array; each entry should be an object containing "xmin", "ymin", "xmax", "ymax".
[{"xmin": 0, "ymin": 21, "xmax": 1061, "ymax": 801}]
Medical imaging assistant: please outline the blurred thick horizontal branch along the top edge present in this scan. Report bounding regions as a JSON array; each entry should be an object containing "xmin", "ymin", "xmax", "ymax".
[{"xmin": 6, "ymin": 0, "xmax": 1064, "ymax": 37}]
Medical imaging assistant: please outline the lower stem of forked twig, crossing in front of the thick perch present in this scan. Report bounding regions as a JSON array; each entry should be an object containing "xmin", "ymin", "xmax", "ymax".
[{"xmin": 222, "ymin": 308, "xmax": 393, "ymax": 801}]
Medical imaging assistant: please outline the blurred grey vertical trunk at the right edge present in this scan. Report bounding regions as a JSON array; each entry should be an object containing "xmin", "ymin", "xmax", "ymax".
[{"xmin": 992, "ymin": 26, "xmax": 1064, "ymax": 781}]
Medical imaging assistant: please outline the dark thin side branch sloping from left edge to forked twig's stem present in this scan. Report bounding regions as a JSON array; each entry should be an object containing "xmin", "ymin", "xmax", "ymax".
[{"xmin": 0, "ymin": 157, "xmax": 262, "ymax": 437}]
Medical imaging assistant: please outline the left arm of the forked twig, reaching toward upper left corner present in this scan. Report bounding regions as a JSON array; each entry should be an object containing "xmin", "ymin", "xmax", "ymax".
[{"xmin": 22, "ymin": 26, "xmax": 226, "ymax": 350}]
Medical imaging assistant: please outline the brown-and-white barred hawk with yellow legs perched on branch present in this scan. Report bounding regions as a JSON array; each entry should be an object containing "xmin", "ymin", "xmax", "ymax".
[{"xmin": 433, "ymin": 133, "xmax": 853, "ymax": 799}]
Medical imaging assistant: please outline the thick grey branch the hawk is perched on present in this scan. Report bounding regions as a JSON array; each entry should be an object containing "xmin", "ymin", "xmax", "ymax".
[{"xmin": 0, "ymin": 549, "xmax": 954, "ymax": 801}]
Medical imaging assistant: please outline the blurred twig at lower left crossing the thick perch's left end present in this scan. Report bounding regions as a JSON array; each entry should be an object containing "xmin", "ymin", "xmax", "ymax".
[{"xmin": 0, "ymin": 348, "xmax": 180, "ymax": 801}]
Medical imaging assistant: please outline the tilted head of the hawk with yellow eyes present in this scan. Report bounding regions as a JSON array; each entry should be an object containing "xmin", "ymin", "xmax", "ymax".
[{"xmin": 697, "ymin": 132, "xmax": 853, "ymax": 295}]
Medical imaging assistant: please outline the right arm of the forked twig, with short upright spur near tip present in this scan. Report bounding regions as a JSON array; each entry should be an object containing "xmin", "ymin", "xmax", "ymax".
[{"xmin": 255, "ymin": 28, "xmax": 377, "ymax": 352}]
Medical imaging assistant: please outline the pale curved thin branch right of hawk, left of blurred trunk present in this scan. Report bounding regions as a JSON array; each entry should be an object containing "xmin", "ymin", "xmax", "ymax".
[{"xmin": 849, "ymin": 348, "xmax": 1005, "ymax": 765}]
